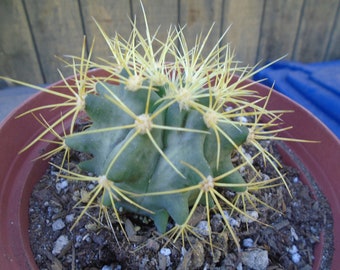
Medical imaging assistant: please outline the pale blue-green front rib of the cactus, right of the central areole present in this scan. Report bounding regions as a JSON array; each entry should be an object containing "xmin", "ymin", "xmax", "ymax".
[{"xmin": 143, "ymin": 107, "xmax": 212, "ymax": 231}]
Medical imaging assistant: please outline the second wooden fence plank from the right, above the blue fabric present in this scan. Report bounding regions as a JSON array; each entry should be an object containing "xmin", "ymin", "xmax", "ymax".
[{"xmin": 294, "ymin": 0, "xmax": 339, "ymax": 62}]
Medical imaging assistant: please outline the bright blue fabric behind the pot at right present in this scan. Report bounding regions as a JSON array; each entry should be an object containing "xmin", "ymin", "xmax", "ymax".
[{"xmin": 254, "ymin": 61, "xmax": 340, "ymax": 138}]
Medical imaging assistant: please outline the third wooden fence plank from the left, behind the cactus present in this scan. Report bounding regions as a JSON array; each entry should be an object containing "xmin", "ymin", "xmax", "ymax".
[{"xmin": 80, "ymin": 0, "xmax": 131, "ymax": 59}]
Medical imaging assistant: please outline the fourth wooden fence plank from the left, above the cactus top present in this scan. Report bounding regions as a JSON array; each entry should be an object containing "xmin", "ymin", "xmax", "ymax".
[{"xmin": 131, "ymin": 0, "xmax": 178, "ymax": 57}]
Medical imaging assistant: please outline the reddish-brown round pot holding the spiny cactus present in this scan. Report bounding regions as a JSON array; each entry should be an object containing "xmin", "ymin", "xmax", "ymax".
[{"xmin": 0, "ymin": 70, "xmax": 340, "ymax": 269}]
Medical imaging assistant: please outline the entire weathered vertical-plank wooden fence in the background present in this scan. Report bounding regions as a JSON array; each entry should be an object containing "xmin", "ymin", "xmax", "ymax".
[{"xmin": 0, "ymin": 0, "xmax": 340, "ymax": 83}]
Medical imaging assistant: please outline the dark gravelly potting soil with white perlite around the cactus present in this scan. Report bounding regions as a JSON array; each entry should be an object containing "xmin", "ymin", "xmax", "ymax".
[{"xmin": 29, "ymin": 142, "xmax": 332, "ymax": 270}]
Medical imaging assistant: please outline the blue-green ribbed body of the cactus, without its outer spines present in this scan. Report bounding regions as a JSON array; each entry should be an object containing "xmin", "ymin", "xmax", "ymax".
[{"xmin": 65, "ymin": 71, "xmax": 249, "ymax": 232}]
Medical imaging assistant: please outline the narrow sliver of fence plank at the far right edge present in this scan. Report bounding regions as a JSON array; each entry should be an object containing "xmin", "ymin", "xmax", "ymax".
[{"xmin": 324, "ymin": 1, "xmax": 340, "ymax": 61}]
